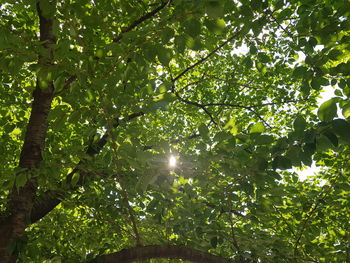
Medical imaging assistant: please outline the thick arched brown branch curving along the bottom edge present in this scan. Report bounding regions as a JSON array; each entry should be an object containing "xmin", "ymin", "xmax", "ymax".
[{"xmin": 90, "ymin": 245, "xmax": 243, "ymax": 263}]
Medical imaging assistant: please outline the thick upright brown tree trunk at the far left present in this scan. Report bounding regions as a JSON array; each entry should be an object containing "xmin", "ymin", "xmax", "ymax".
[{"xmin": 0, "ymin": 3, "xmax": 55, "ymax": 263}]
